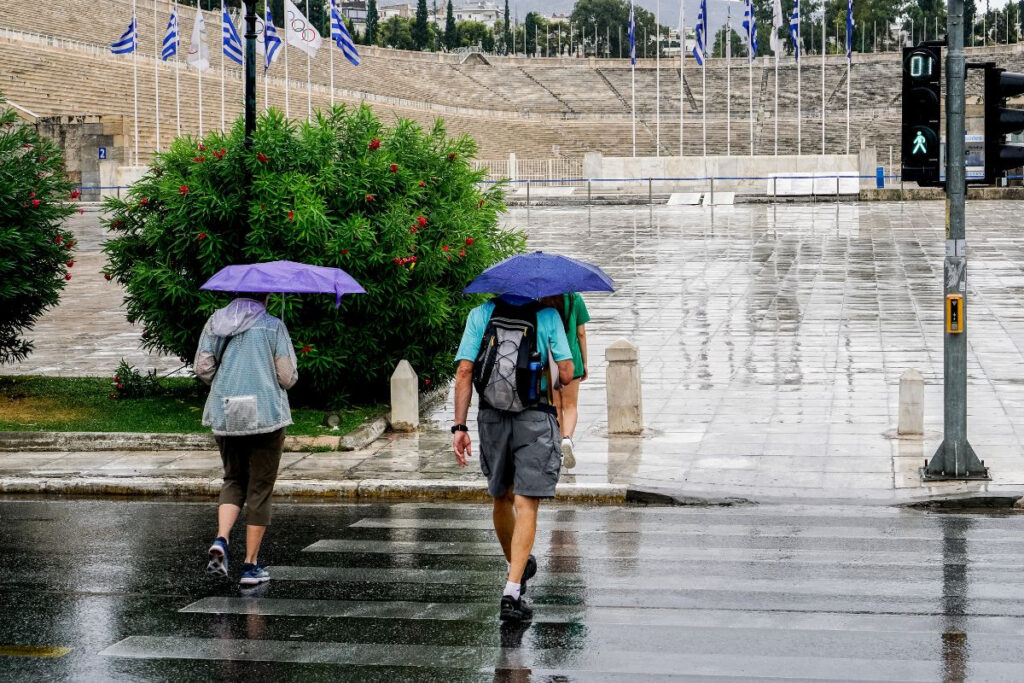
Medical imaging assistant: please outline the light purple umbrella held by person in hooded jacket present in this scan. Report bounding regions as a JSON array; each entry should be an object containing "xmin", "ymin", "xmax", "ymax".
[{"xmin": 200, "ymin": 261, "xmax": 367, "ymax": 307}]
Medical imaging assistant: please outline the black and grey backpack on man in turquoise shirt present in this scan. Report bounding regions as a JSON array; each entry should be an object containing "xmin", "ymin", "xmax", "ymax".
[{"xmin": 473, "ymin": 299, "xmax": 547, "ymax": 413}]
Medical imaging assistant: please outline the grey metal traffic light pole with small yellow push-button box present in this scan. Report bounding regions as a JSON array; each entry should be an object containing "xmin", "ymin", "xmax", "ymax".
[{"xmin": 922, "ymin": 0, "xmax": 988, "ymax": 480}]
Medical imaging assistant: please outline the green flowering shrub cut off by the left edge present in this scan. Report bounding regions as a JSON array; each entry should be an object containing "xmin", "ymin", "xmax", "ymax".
[{"xmin": 0, "ymin": 96, "xmax": 77, "ymax": 365}]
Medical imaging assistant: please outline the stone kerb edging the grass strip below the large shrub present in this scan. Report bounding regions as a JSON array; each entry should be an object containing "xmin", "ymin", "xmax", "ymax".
[{"xmin": 0, "ymin": 416, "xmax": 388, "ymax": 453}]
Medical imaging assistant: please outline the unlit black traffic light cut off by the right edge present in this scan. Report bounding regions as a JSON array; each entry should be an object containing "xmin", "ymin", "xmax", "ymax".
[{"xmin": 985, "ymin": 65, "xmax": 1024, "ymax": 183}]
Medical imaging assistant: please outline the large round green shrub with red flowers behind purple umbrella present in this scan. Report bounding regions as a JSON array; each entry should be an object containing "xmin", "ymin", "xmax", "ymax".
[{"xmin": 104, "ymin": 106, "xmax": 524, "ymax": 402}]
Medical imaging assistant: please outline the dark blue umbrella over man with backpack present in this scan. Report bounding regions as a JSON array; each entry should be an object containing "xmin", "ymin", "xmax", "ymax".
[{"xmin": 462, "ymin": 252, "xmax": 615, "ymax": 299}]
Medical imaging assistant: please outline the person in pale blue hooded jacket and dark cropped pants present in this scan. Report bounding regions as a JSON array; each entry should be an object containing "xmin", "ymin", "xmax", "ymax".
[{"xmin": 195, "ymin": 293, "xmax": 299, "ymax": 586}]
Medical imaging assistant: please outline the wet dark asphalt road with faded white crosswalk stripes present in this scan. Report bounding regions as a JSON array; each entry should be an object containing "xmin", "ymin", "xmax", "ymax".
[{"xmin": 0, "ymin": 499, "xmax": 1024, "ymax": 681}]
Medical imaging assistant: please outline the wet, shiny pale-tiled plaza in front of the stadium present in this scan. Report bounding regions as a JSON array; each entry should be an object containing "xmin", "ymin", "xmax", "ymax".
[{"xmin": 4, "ymin": 202, "xmax": 1024, "ymax": 502}]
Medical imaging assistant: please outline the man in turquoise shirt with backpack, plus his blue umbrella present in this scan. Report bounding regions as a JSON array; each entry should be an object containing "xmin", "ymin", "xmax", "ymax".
[{"xmin": 452, "ymin": 252, "xmax": 612, "ymax": 622}]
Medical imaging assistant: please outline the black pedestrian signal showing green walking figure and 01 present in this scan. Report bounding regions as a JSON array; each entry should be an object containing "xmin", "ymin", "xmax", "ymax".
[{"xmin": 902, "ymin": 45, "xmax": 942, "ymax": 185}]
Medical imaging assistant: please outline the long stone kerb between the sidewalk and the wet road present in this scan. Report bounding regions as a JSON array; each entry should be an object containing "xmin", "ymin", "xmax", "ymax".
[{"xmin": 0, "ymin": 476, "xmax": 627, "ymax": 505}]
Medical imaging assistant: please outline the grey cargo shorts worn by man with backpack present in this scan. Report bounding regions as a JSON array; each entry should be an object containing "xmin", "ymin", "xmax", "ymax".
[{"xmin": 476, "ymin": 408, "xmax": 562, "ymax": 498}]
